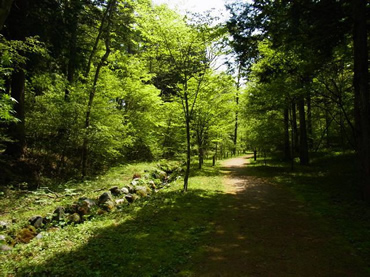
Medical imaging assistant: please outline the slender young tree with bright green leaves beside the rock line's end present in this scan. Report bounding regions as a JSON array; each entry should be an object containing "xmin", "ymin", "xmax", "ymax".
[{"xmin": 141, "ymin": 5, "xmax": 220, "ymax": 191}]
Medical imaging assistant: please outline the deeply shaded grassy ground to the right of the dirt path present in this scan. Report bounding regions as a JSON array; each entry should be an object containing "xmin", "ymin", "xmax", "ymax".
[{"xmin": 247, "ymin": 153, "xmax": 370, "ymax": 267}]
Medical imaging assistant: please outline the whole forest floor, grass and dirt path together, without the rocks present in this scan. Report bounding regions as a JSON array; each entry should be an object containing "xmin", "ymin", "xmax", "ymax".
[{"xmin": 0, "ymin": 153, "xmax": 370, "ymax": 277}]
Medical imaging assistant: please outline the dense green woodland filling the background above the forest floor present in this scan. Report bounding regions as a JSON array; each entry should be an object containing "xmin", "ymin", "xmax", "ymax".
[{"xmin": 0, "ymin": 0, "xmax": 370, "ymax": 200}]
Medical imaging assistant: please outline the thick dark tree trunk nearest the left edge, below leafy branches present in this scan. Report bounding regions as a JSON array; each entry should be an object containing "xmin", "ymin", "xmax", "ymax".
[{"xmin": 5, "ymin": 69, "xmax": 26, "ymax": 158}]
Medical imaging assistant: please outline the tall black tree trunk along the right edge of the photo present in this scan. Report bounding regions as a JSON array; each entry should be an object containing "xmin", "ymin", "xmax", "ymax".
[{"xmin": 352, "ymin": 0, "xmax": 370, "ymax": 201}]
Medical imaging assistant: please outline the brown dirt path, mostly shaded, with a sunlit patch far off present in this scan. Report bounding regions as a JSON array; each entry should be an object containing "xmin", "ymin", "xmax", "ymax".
[{"xmin": 194, "ymin": 155, "xmax": 370, "ymax": 277}]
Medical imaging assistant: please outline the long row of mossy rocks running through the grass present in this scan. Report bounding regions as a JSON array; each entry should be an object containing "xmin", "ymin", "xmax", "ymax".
[{"xmin": 0, "ymin": 163, "xmax": 182, "ymax": 248}]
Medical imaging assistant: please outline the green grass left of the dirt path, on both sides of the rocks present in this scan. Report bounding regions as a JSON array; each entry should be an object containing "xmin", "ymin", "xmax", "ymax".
[{"xmin": 0, "ymin": 158, "xmax": 223, "ymax": 276}]
